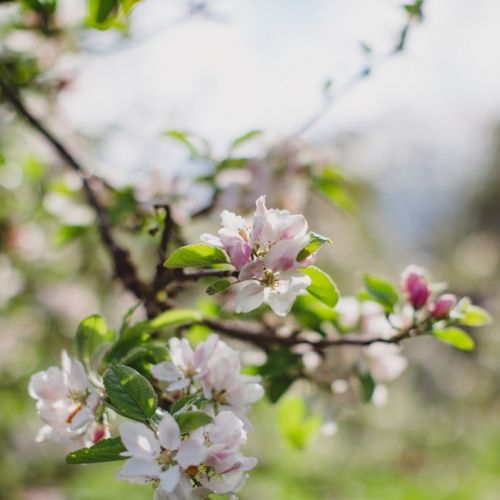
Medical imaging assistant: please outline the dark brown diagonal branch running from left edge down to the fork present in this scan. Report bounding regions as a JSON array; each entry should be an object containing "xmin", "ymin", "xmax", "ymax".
[{"xmin": 0, "ymin": 68, "xmax": 145, "ymax": 299}]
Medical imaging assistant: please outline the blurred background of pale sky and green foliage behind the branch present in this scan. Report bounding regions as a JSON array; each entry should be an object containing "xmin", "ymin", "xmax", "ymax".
[{"xmin": 0, "ymin": 0, "xmax": 500, "ymax": 500}]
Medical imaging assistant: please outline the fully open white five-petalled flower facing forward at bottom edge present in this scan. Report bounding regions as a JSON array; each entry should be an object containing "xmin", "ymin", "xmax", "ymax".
[{"xmin": 118, "ymin": 413, "xmax": 207, "ymax": 498}]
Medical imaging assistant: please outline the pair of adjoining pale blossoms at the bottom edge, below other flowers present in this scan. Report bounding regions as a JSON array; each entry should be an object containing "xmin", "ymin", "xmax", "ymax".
[{"xmin": 118, "ymin": 411, "xmax": 256, "ymax": 500}]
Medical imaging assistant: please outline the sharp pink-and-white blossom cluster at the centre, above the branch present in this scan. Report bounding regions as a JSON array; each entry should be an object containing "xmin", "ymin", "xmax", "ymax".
[{"xmin": 201, "ymin": 196, "xmax": 315, "ymax": 316}]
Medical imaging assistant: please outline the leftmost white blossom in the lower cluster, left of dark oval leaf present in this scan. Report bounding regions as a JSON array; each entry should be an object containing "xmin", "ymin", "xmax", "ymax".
[{"xmin": 28, "ymin": 351, "xmax": 100, "ymax": 443}]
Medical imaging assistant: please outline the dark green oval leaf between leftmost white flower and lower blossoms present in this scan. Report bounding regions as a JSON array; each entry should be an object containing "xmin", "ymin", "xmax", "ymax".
[{"xmin": 104, "ymin": 365, "xmax": 158, "ymax": 422}]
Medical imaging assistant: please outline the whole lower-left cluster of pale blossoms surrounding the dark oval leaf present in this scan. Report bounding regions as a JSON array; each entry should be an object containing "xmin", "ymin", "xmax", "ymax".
[{"xmin": 29, "ymin": 335, "xmax": 264, "ymax": 500}]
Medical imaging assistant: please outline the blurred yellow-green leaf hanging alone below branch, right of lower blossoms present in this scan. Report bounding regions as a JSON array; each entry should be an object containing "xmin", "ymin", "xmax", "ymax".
[{"xmin": 277, "ymin": 396, "xmax": 321, "ymax": 450}]
